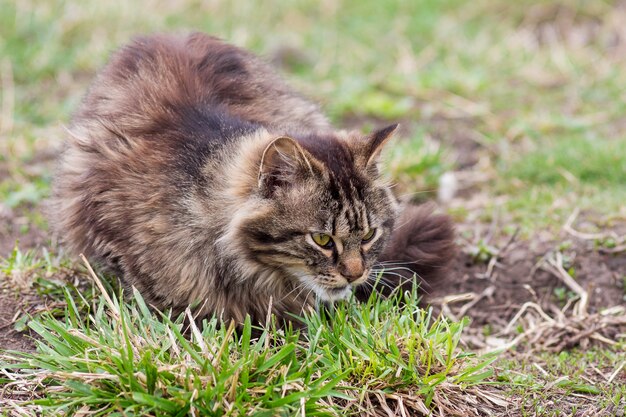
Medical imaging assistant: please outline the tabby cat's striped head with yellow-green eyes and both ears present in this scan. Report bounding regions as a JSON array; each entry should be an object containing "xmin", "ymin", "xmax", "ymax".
[{"xmin": 238, "ymin": 125, "xmax": 397, "ymax": 301}]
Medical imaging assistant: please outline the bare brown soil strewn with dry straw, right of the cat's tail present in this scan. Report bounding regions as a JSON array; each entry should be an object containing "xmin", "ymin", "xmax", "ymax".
[{"xmin": 424, "ymin": 226, "xmax": 626, "ymax": 351}]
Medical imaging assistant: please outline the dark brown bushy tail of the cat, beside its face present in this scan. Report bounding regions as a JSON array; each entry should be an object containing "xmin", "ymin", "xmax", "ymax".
[{"xmin": 357, "ymin": 204, "xmax": 456, "ymax": 298}]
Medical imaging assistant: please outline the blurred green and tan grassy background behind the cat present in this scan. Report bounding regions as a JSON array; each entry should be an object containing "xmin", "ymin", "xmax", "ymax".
[{"xmin": 0, "ymin": 0, "xmax": 626, "ymax": 240}]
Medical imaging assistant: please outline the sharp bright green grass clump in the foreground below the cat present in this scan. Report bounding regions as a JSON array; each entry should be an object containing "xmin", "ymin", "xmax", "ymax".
[{"xmin": 0, "ymin": 260, "xmax": 494, "ymax": 416}]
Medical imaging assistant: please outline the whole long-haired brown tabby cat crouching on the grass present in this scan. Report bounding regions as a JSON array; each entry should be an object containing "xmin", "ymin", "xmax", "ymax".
[{"xmin": 52, "ymin": 33, "xmax": 453, "ymax": 322}]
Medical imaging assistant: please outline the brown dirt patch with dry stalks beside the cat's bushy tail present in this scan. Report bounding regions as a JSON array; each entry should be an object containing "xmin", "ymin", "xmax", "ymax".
[{"xmin": 424, "ymin": 218, "xmax": 626, "ymax": 350}]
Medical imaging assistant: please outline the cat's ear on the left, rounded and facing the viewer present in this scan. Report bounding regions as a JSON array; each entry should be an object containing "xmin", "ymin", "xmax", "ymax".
[{"xmin": 259, "ymin": 136, "xmax": 319, "ymax": 196}]
